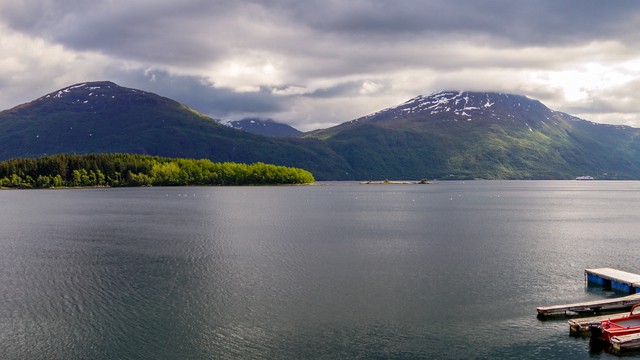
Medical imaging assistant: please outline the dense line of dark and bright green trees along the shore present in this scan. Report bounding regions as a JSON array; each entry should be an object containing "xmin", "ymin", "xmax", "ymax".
[{"xmin": 0, "ymin": 154, "xmax": 314, "ymax": 188}]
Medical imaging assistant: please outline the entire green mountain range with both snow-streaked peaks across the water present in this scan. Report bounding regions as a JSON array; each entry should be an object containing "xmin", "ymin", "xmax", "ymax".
[{"xmin": 0, "ymin": 81, "xmax": 640, "ymax": 180}]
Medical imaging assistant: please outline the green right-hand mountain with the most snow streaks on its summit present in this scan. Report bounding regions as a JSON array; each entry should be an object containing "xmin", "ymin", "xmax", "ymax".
[{"xmin": 305, "ymin": 91, "xmax": 640, "ymax": 179}]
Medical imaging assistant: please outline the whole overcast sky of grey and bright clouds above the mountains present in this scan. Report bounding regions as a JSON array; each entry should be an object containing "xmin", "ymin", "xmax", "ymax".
[{"xmin": 0, "ymin": 0, "xmax": 640, "ymax": 130}]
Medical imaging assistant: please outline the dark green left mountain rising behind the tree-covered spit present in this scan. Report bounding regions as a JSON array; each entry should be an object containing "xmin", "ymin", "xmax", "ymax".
[{"xmin": 0, "ymin": 81, "xmax": 350, "ymax": 177}]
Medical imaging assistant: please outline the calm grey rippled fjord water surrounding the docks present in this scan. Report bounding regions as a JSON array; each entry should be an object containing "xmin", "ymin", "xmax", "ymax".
[{"xmin": 0, "ymin": 181, "xmax": 640, "ymax": 359}]
